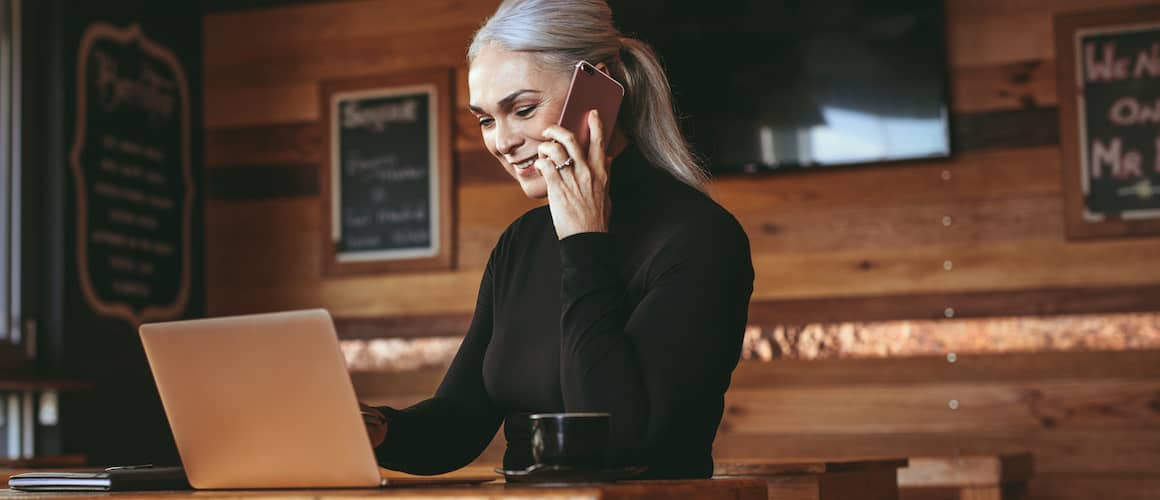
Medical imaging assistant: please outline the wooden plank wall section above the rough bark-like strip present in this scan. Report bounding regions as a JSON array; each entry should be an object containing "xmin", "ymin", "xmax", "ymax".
[{"xmin": 205, "ymin": 0, "xmax": 1160, "ymax": 334}]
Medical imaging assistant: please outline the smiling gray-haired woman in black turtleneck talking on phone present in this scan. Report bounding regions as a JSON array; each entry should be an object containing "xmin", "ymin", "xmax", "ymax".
[{"xmin": 364, "ymin": 0, "xmax": 753, "ymax": 478}]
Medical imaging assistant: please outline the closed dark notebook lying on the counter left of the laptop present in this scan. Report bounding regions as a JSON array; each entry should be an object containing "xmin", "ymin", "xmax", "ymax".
[{"xmin": 8, "ymin": 466, "xmax": 189, "ymax": 492}]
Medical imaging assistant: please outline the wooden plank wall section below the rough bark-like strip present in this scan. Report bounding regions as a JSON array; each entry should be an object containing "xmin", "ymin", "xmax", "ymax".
[{"xmin": 354, "ymin": 350, "xmax": 1160, "ymax": 500}]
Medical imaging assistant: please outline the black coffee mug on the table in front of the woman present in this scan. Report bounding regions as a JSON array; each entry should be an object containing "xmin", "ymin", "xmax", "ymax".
[{"xmin": 529, "ymin": 413, "xmax": 611, "ymax": 469}]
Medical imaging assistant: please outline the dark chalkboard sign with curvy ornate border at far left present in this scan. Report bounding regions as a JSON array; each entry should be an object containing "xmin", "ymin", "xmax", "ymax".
[{"xmin": 70, "ymin": 21, "xmax": 195, "ymax": 326}]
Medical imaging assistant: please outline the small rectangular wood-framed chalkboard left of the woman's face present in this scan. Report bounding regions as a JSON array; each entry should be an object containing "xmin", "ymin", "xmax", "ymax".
[{"xmin": 321, "ymin": 71, "xmax": 451, "ymax": 274}]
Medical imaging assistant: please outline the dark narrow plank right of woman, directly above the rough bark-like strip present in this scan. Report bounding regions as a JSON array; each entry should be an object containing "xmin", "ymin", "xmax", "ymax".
[{"xmin": 749, "ymin": 285, "xmax": 1160, "ymax": 327}]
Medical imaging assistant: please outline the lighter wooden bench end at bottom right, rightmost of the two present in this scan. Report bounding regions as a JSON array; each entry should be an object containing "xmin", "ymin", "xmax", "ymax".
[{"xmin": 898, "ymin": 454, "xmax": 1035, "ymax": 500}]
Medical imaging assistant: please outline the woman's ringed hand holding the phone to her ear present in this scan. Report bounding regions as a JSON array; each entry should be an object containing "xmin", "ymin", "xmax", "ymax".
[{"xmin": 535, "ymin": 110, "xmax": 612, "ymax": 240}]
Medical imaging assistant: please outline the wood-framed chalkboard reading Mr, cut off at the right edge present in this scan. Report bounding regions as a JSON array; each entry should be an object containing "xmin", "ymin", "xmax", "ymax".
[{"xmin": 1056, "ymin": 7, "xmax": 1160, "ymax": 238}]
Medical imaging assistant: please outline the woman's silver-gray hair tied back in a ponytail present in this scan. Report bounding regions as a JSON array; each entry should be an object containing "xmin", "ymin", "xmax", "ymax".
[{"xmin": 467, "ymin": 0, "xmax": 708, "ymax": 191}]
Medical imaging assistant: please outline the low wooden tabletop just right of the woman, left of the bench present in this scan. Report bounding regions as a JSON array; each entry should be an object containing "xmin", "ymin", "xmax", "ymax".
[{"xmin": 713, "ymin": 458, "xmax": 907, "ymax": 500}]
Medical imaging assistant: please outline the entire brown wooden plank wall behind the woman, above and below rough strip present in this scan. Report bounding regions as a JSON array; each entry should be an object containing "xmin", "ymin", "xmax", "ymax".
[{"xmin": 204, "ymin": 0, "xmax": 1160, "ymax": 499}]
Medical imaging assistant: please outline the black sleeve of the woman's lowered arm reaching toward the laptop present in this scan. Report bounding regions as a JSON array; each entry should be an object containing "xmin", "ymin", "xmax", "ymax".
[{"xmin": 375, "ymin": 262, "xmax": 502, "ymax": 474}]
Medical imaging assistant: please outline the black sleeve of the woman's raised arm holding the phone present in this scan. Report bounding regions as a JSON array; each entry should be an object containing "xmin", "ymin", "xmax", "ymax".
[{"xmin": 560, "ymin": 220, "xmax": 753, "ymax": 477}]
